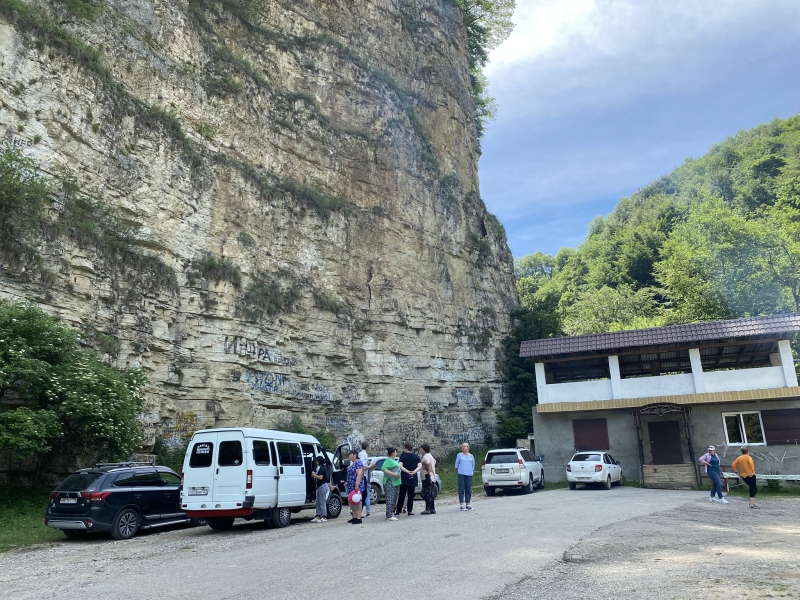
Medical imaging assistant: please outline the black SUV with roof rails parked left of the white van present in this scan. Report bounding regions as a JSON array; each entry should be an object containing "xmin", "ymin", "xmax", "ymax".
[{"xmin": 44, "ymin": 463, "xmax": 206, "ymax": 540}]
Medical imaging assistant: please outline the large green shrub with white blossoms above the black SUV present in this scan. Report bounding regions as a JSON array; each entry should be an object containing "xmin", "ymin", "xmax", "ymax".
[{"xmin": 0, "ymin": 300, "xmax": 145, "ymax": 479}]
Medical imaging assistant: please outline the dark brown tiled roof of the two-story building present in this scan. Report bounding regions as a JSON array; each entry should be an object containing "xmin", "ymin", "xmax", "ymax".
[{"xmin": 519, "ymin": 313, "xmax": 800, "ymax": 357}]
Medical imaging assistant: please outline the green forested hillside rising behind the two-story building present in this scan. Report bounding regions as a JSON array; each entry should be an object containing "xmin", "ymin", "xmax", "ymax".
[{"xmin": 499, "ymin": 115, "xmax": 800, "ymax": 437}]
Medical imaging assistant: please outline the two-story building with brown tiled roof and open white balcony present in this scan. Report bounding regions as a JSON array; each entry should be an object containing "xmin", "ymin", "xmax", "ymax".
[{"xmin": 520, "ymin": 313, "xmax": 800, "ymax": 487}]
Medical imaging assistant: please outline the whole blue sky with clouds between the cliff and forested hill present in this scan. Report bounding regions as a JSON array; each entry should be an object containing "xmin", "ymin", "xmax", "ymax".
[{"xmin": 479, "ymin": 0, "xmax": 800, "ymax": 258}]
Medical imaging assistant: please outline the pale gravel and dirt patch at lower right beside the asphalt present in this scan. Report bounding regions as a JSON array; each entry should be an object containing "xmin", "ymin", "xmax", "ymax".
[{"xmin": 491, "ymin": 497, "xmax": 800, "ymax": 600}]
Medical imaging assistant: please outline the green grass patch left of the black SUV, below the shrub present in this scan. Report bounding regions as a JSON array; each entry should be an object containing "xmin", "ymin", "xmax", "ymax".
[{"xmin": 0, "ymin": 485, "xmax": 65, "ymax": 552}]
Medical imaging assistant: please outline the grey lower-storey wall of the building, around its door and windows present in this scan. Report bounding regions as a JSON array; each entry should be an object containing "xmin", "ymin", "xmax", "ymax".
[{"xmin": 533, "ymin": 400, "xmax": 800, "ymax": 481}]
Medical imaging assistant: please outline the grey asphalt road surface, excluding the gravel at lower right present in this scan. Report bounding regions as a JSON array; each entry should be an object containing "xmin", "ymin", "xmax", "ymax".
[{"xmin": 0, "ymin": 487, "xmax": 756, "ymax": 600}]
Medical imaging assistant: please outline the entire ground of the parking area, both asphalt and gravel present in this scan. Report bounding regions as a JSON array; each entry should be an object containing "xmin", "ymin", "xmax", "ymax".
[{"xmin": 0, "ymin": 487, "xmax": 800, "ymax": 600}]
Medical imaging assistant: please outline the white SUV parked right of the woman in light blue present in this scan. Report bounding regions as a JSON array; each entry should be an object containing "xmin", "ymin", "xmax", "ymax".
[{"xmin": 481, "ymin": 448, "xmax": 544, "ymax": 496}]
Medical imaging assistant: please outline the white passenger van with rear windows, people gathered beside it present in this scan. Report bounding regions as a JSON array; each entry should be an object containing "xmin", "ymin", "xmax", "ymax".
[{"xmin": 181, "ymin": 428, "xmax": 342, "ymax": 529}]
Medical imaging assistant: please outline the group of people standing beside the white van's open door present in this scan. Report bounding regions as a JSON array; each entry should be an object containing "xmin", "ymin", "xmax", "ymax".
[{"xmin": 311, "ymin": 442, "xmax": 475, "ymax": 525}]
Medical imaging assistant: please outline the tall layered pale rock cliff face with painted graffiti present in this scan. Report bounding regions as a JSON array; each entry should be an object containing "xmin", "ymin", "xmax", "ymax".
[{"xmin": 0, "ymin": 0, "xmax": 516, "ymax": 449}]
